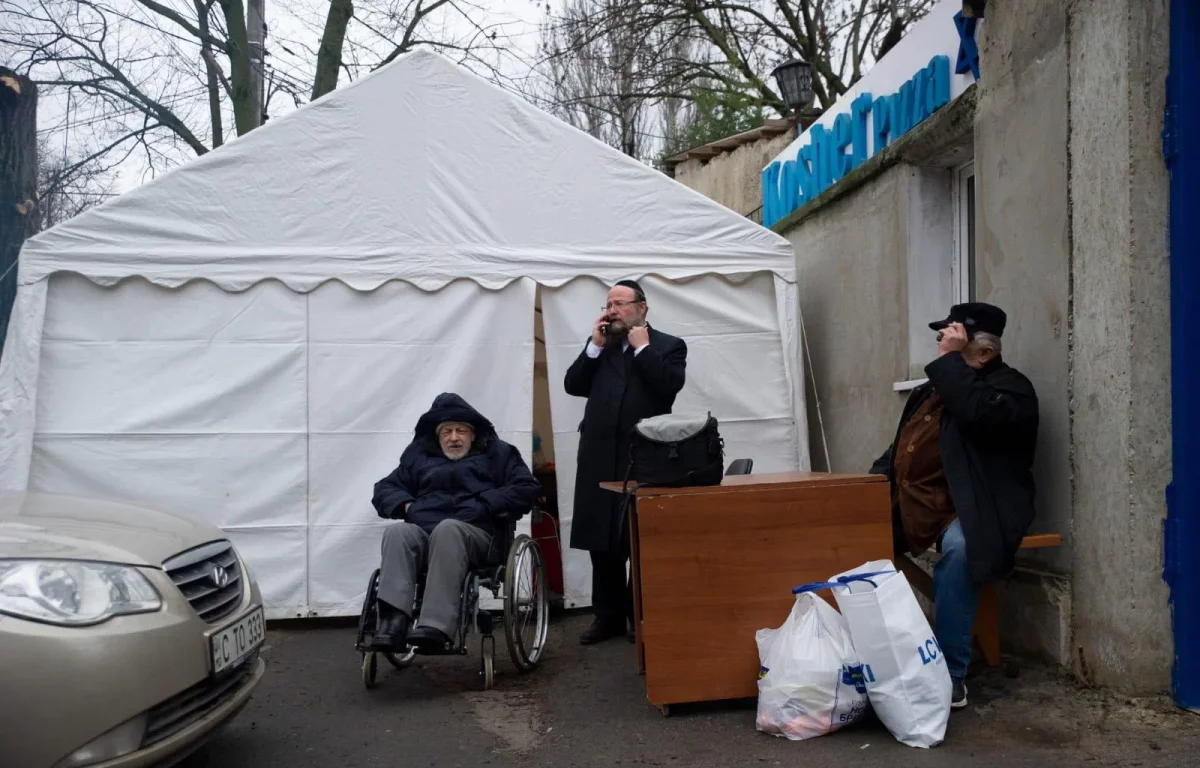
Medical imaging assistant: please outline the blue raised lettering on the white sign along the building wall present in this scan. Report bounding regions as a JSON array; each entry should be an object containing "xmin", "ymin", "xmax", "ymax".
[{"xmin": 762, "ymin": 56, "xmax": 950, "ymax": 227}]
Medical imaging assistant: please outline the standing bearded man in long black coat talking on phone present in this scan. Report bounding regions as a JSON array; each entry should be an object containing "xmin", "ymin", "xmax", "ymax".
[{"xmin": 565, "ymin": 280, "xmax": 688, "ymax": 646}]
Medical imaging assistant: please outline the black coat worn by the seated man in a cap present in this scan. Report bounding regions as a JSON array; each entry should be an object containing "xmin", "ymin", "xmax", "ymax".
[{"xmin": 871, "ymin": 353, "xmax": 1038, "ymax": 582}]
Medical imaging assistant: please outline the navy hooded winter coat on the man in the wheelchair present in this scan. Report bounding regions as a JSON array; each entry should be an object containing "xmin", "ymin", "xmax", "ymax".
[{"xmin": 371, "ymin": 394, "xmax": 540, "ymax": 534}]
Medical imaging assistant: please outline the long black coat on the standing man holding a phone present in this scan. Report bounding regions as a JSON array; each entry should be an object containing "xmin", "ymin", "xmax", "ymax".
[{"xmin": 564, "ymin": 328, "xmax": 688, "ymax": 553}]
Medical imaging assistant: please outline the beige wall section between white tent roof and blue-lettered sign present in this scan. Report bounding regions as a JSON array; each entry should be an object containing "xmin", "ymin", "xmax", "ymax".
[{"xmin": 674, "ymin": 128, "xmax": 796, "ymax": 216}]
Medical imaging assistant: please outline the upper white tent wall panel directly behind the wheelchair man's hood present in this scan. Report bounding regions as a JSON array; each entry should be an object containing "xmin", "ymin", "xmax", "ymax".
[{"xmin": 308, "ymin": 280, "xmax": 535, "ymax": 441}]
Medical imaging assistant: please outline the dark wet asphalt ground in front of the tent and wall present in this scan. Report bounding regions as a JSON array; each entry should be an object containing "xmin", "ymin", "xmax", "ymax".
[{"xmin": 184, "ymin": 616, "xmax": 1200, "ymax": 768}]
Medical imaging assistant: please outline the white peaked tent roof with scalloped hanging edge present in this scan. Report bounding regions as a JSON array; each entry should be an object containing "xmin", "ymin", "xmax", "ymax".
[{"xmin": 20, "ymin": 50, "xmax": 794, "ymax": 290}]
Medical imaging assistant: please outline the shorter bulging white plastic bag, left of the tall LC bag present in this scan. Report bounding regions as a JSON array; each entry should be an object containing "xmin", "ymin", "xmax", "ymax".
[{"xmin": 755, "ymin": 592, "xmax": 866, "ymax": 740}]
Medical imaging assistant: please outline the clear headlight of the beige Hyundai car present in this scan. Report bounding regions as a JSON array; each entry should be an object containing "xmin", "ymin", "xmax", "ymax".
[{"xmin": 0, "ymin": 560, "xmax": 162, "ymax": 626}]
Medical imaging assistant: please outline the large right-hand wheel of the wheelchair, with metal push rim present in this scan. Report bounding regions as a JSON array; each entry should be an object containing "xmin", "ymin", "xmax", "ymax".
[{"xmin": 504, "ymin": 534, "xmax": 550, "ymax": 672}]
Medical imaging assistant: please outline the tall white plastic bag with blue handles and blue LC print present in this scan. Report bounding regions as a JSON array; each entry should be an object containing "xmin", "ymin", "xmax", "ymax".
[{"xmin": 829, "ymin": 560, "xmax": 950, "ymax": 748}]
